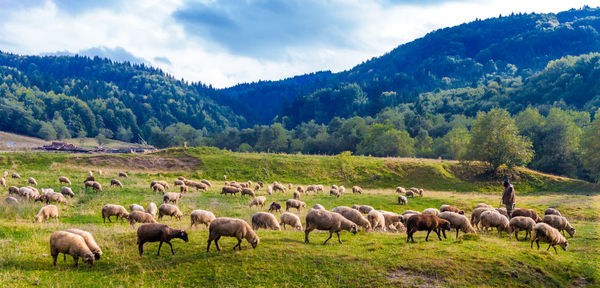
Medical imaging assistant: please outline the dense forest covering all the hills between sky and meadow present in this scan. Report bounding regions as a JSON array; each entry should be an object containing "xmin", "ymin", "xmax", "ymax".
[{"xmin": 0, "ymin": 7, "xmax": 600, "ymax": 180}]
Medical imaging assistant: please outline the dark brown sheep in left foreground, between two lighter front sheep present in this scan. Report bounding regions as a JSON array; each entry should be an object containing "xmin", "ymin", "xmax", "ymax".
[{"xmin": 137, "ymin": 223, "xmax": 188, "ymax": 257}]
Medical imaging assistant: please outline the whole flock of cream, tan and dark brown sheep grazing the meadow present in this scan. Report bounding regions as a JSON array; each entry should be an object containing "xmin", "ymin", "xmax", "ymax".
[{"xmin": 0, "ymin": 171, "xmax": 575, "ymax": 266}]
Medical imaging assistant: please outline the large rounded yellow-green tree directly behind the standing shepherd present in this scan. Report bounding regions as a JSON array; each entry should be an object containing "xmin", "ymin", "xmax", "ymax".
[{"xmin": 469, "ymin": 108, "xmax": 534, "ymax": 170}]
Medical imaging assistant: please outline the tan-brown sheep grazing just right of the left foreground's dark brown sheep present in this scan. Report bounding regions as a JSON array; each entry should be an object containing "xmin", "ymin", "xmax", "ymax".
[{"xmin": 206, "ymin": 217, "xmax": 260, "ymax": 253}]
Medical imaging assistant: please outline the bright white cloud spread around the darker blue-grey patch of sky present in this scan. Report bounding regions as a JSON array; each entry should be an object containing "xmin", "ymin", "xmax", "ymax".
[{"xmin": 0, "ymin": 0, "xmax": 600, "ymax": 87}]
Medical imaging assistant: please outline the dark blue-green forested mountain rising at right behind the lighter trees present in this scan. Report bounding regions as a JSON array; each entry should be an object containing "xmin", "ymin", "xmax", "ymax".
[{"xmin": 221, "ymin": 7, "xmax": 600, "ymax": 127}]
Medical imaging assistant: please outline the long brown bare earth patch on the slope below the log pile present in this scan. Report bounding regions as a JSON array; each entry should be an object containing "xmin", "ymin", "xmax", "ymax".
[{"xmin": 70, "ymin": 153, "xmax": 202, "ymax": 171}]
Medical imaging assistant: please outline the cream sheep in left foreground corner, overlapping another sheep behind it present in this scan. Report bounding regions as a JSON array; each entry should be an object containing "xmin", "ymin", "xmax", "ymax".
[{"xmin": 50, "ymin": 231, "xmax": 95, "ymax": 267}]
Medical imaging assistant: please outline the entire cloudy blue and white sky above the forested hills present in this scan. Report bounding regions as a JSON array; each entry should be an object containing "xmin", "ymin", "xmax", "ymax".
[{"xmin": 0, "ymin": 0, "xmax": 600, "ymax": 88}]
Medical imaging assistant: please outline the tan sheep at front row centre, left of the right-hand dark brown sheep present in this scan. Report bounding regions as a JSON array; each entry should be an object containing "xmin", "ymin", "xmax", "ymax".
[{"xmin": 304, "ymin": 209, "xmax": 362, "ymax": 245}]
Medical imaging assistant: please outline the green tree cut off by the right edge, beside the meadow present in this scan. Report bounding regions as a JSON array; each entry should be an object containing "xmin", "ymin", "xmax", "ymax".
[{"xmin": 581, "ymin": 110, "xmax": 600, "ymax": 182}]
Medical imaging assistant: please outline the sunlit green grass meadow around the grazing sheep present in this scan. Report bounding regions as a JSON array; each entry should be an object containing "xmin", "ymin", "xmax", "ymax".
[{"xmin": 0, "ymin": 148, "xmax": 600, "ymax": 287}]
